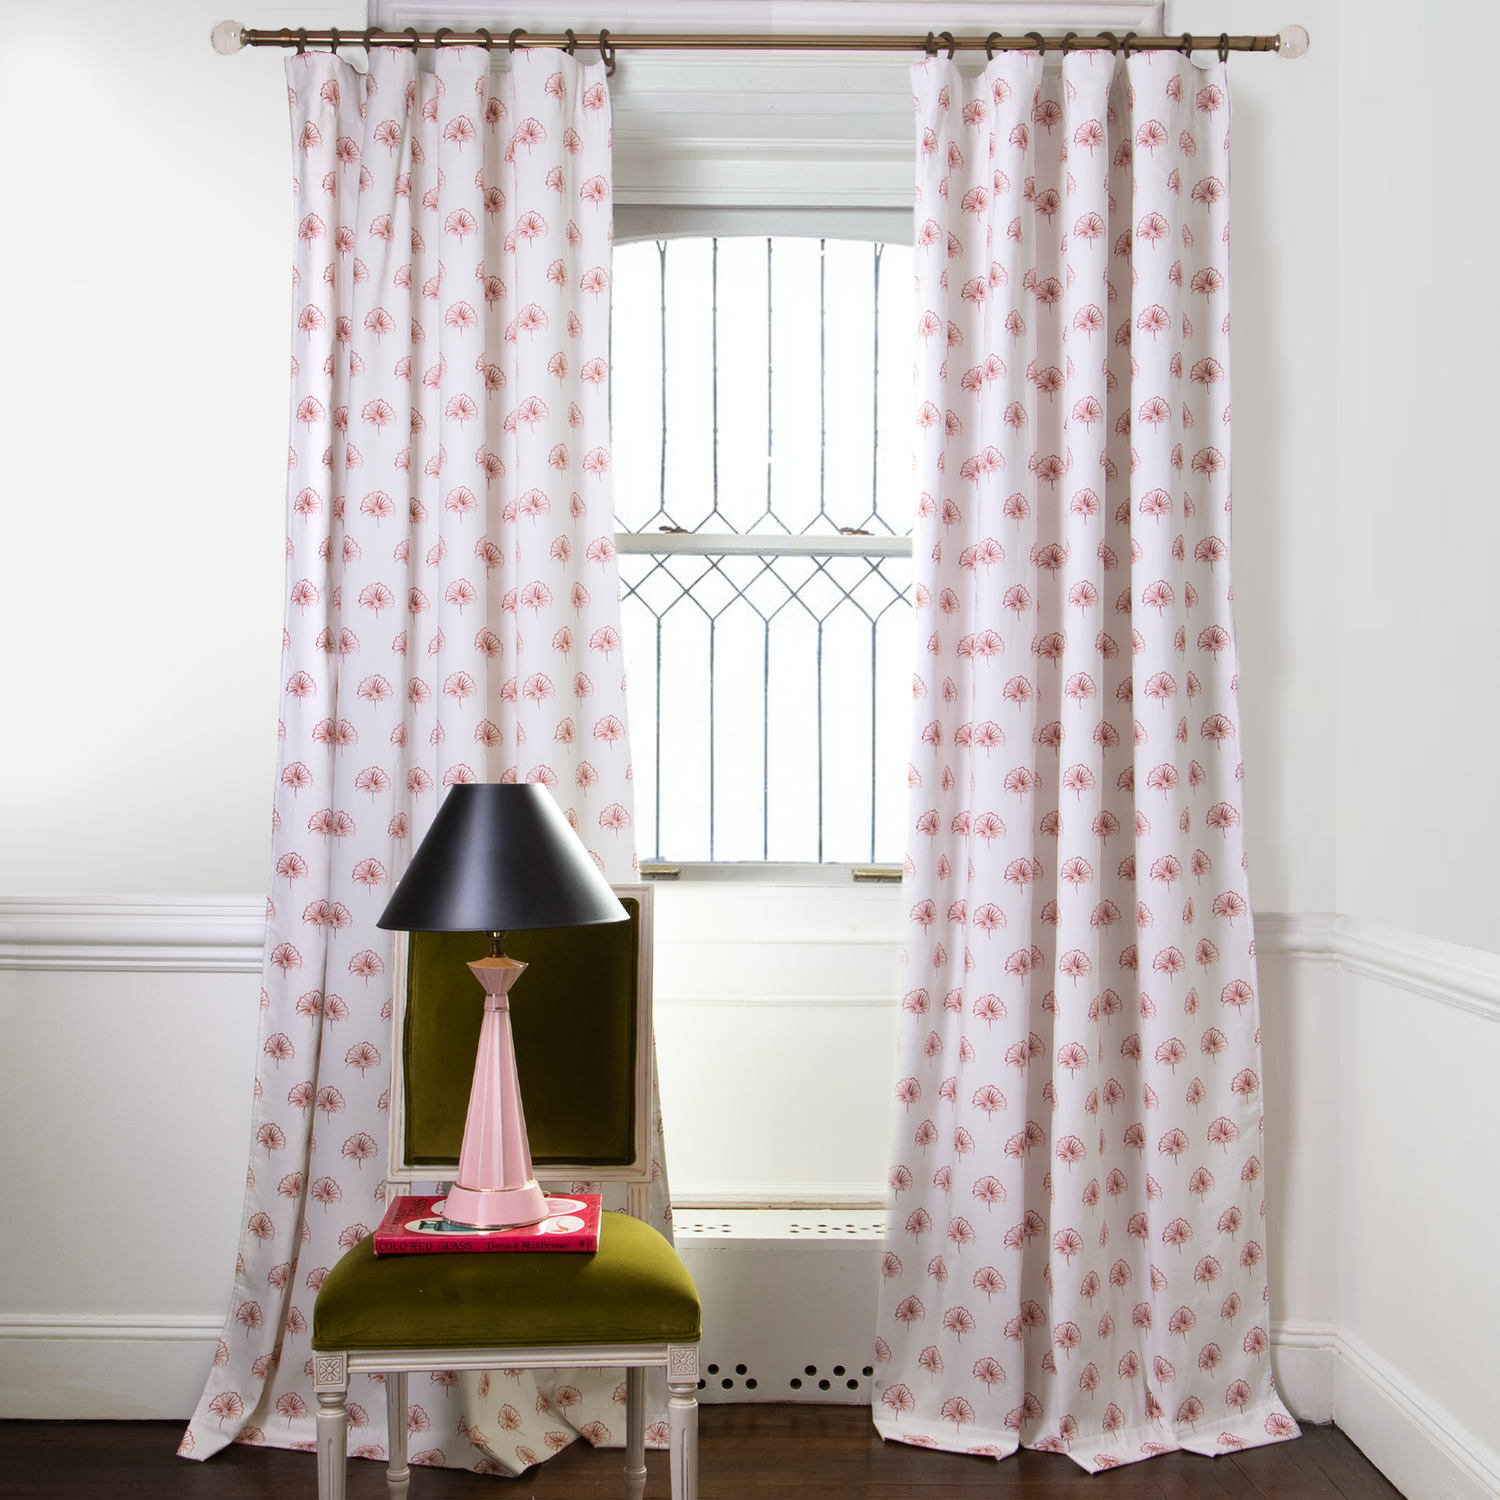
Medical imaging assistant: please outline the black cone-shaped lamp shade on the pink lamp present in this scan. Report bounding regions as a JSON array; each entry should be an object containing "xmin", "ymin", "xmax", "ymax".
[{"xmin": 377, "ymin": 782, "xmax": 627, "ymax": 933}]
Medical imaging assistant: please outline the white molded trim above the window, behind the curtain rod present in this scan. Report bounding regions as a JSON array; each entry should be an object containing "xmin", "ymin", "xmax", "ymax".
[{"xmin": 369, "ymin": 0, "xmax": 1163, "ymax": 213}]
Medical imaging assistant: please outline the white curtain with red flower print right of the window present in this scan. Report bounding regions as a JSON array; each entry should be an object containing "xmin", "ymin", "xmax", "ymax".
[{"xmin": 875, "ymin": 53, "xmax": 1298, "ymax": 1472}]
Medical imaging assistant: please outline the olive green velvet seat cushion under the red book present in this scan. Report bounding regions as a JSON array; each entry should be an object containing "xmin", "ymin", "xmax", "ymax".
[{"xmin": 312, "ymin": 1214, "xmax": 702, "ymax": 1350}]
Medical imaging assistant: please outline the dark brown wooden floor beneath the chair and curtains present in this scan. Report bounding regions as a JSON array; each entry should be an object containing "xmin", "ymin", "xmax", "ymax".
[{"xmin": 0, "ymin": 1406, "xmax": 1400, "ymax": 1500}]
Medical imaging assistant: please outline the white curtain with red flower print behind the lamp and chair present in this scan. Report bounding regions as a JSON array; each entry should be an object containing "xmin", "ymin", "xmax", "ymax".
[{"xmin": 182, "ymin": 47, "xmax": 671, "ymax": 1473}]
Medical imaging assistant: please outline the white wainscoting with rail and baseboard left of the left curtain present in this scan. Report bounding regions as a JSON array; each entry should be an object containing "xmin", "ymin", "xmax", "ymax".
[{"xmin": 0, "ymin": 897, "xmax": 266, "ymax": 1418}]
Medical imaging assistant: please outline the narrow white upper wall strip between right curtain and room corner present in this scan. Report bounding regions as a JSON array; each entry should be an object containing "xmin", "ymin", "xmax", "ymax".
[{"xmin": 1166, "ymin": 0, "xmax": 1341, "ymax": 912}]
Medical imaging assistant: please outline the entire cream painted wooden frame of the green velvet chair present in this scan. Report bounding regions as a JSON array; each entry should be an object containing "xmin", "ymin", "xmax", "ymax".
[{"xmin": 312, "ymin": 885, "xmax": 698, "ymax": 1500}]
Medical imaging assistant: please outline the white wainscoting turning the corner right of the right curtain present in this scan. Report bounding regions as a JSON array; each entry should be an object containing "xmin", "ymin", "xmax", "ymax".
[{"xmin": 1256, "ymin": 914, "xmax": 1500, "ymax": 1500}]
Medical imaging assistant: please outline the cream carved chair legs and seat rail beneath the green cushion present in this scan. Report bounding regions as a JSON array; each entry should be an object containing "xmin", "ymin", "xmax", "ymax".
[{"xmin": 312, "ymin": 1344, "xmax": 698, "ymax": 1500}]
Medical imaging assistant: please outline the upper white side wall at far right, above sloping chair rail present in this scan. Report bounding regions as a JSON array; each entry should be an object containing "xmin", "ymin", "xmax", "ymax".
[{"xmin": 1325, "ymin": 0, "xmax": 1500, "ymax": 951}]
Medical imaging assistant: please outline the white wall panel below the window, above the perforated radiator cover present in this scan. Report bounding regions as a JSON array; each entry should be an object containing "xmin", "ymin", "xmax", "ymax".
[{"xmin": 656, "ymin": 882, "xmax": 906, "ymax": 1206}]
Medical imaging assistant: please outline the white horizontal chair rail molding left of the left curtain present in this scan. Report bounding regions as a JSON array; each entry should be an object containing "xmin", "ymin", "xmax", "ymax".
[{"xmin": 0, "ymin": 896, "xmax": 266, "ymax": 974}]
